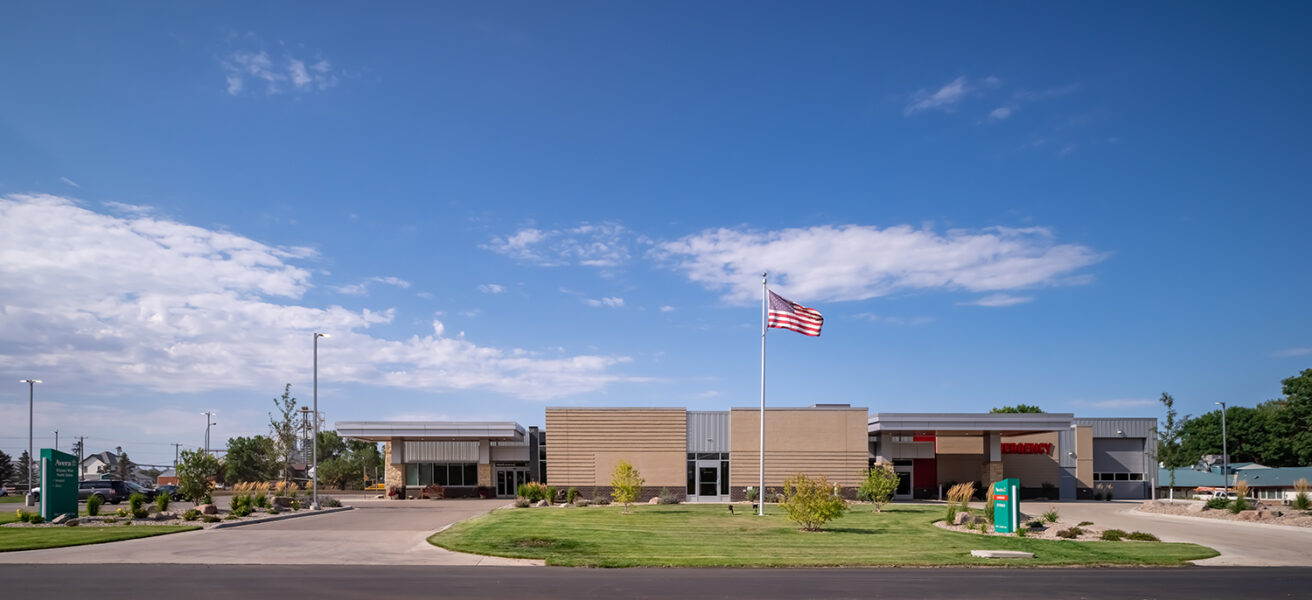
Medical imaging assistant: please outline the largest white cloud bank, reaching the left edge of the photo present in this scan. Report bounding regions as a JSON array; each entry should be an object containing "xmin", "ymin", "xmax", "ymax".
[{"xmin": 0, "ymin": 196, "xmax": 630, "ymax": 398}]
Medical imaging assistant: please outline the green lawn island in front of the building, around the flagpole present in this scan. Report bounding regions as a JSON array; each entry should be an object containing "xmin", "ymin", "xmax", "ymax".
[{"xmin": 429, "ymin": 504, "xmax": 1218, "ymax": 567}]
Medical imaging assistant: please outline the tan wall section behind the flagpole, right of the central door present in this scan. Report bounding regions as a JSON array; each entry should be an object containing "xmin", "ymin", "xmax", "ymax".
[{"xmin": 734, "ymin": 408, "xmax": 870, "ymax": 487}]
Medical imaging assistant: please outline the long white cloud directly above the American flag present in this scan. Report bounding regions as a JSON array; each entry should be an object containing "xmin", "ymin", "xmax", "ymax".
[{"xmin": 657, "ymin": 225, "xmax": 1103, "ymax": 303}]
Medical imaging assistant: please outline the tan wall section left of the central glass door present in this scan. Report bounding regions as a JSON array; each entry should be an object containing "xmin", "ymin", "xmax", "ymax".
[{"xmin": 546, "ymin": 408, "xmax": 687, "ymax": 490}]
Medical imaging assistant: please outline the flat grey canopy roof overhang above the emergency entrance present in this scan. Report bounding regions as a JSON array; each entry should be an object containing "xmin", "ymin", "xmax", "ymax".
[{"xmin": 866, "ymin": 412, "xmax": 1075, "ymax": 436}]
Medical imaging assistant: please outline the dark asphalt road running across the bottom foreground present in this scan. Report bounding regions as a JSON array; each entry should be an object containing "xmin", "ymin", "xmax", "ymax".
[{"xmin": 0, "ymin": 565, "xmax": 1312, "ymax": 600}]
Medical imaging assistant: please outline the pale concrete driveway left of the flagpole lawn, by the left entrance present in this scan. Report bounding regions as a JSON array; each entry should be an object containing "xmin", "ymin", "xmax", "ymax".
[{"xmin": 0, "ymin": 499, "xmax": 541, "ymax": 565}]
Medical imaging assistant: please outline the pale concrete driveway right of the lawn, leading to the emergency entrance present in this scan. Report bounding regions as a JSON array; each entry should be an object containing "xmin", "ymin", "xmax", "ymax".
[{"xmin": 1021, "ymin": 500, "xmax": 1312, "ymax": 567}]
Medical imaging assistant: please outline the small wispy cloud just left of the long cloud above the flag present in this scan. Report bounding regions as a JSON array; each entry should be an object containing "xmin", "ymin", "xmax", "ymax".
[{"xmin": 483, "ymin": 222, "xmax": 630, "ymax": 268}]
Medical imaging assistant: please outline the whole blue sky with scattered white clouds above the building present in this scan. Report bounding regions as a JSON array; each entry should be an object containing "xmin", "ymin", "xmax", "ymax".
[{"xmin": 0, "ymin": 3, "xmax": 1312, "ymax": 462}]
